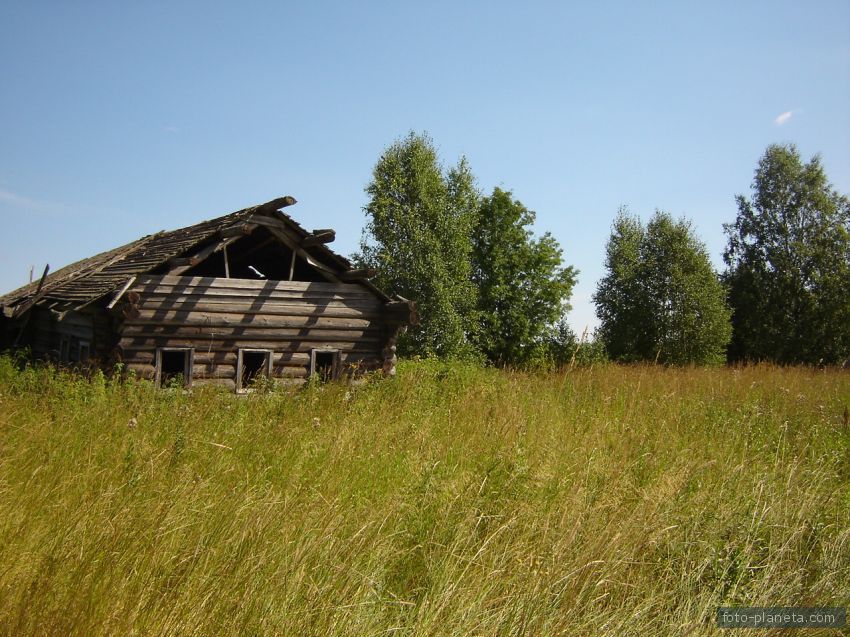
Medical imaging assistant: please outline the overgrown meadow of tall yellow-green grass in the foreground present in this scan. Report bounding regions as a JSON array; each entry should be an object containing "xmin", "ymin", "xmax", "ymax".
[{"xmin": 0, "ymin": 358, "xmax": 850, "ymax": 636}]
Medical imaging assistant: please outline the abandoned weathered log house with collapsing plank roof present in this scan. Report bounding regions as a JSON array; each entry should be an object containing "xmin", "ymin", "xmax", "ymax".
[{"xmin": 0, "ymin": 197, "xmax": 417, "ymax": 392}]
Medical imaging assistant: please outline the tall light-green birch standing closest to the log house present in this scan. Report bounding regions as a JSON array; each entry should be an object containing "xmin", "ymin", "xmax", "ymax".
[{"xmin": 356, "ymin": 132, "xmax": 478, "ymax": 357}]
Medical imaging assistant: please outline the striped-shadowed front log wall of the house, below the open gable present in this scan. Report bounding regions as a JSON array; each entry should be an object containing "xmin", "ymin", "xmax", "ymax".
[{"xmin": 115, "ymin": 275, "xmax": 388, "ymax": 390}]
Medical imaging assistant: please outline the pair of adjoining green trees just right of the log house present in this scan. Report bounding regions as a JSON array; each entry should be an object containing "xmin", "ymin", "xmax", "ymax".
[{"xmin": 355, "ymin": 132, "xmax": 576, "ymax": 365}]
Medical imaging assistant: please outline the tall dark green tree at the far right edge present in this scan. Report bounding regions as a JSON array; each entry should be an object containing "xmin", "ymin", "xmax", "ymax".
[{"xmin": 724, "ymin": 145, "xmax": 850, "ymax": 363}]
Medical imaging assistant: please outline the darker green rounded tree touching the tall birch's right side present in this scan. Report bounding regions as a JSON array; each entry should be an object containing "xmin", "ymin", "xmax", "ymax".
[{"xmin": 472, "ymin": 188, "xmax": 576, "ymax": 365}]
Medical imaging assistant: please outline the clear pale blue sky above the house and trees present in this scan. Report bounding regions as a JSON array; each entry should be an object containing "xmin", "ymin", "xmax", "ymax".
[{"xmin": 0, "ymin": 0, "xmax": 850, "ymax": 332}]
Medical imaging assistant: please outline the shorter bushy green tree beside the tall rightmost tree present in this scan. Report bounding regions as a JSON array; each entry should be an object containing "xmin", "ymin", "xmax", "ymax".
[{"xmin": 594, "ymin": 209, "xmax": 731, "ymax": 365}]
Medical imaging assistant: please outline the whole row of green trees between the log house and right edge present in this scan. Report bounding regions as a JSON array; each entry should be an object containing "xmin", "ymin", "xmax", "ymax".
[{"xmin": 354, "ymin": 132, "xmax": 850, "ymax": 366}]
